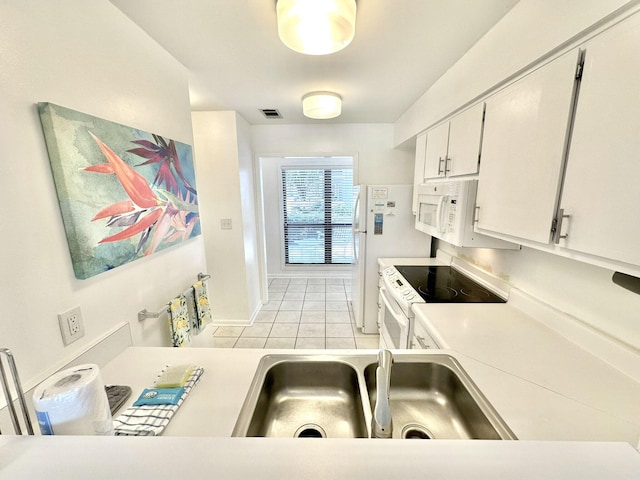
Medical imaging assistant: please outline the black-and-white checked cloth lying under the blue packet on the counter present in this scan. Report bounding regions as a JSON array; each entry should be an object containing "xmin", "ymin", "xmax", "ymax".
[{"xmin": 113, "ymin": 365, "xmax": 204, "ymax": 436}]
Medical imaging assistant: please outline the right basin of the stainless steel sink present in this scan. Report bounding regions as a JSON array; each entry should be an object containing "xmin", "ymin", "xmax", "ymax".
[{"xmin": 364, "ymin": 355, "xmax": 513, "ymax": 440}]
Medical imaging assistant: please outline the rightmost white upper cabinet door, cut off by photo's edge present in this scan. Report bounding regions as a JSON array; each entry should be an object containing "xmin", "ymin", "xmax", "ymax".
[{"xmin": 560, "ymin": 15, "xmax": 640, "ymax": 265}]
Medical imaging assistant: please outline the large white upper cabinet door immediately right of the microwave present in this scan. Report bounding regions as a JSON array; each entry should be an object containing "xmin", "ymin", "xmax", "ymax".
[{"xmin": 477, "ymin": 51, "xmax": 579, "ymax": 243}]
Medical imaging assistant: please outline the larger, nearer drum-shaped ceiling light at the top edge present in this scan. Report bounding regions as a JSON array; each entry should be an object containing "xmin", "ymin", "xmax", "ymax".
[{"xmin": 276, "ymin": 0, "xmax": 356, "ymax": 55}]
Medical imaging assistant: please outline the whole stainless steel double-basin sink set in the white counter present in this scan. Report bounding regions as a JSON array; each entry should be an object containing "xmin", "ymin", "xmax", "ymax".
[{"xmin": 232, "ymin": 353, "xmax": 516, "ymax": 440}]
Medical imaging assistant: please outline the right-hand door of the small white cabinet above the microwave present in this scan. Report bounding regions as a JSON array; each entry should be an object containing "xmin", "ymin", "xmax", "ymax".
[{"xmin": 445, "ymin": 103, "xmax": 484, "ymax": 177}]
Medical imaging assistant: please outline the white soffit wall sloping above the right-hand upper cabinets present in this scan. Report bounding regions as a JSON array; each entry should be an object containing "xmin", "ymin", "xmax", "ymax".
[{"xmin": 394, "ymin": 0, "xmax": 638, "ymax": 145}]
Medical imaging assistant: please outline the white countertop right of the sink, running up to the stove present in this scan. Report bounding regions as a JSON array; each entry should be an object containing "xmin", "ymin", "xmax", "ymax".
[{"xmin": 413, "ymin": 303, "xmax": 640, "ymax": 446}]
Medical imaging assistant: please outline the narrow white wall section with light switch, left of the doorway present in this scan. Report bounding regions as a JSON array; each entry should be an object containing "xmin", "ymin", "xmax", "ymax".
[{"xmin": 192, "ymin": 111, "xmax": 261, "ymax": 324}]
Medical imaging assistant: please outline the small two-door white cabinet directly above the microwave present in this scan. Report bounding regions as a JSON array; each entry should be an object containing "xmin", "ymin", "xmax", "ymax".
[{"xmin": 421, "ymin": 103, "xmax": 484, "ymax": 183}]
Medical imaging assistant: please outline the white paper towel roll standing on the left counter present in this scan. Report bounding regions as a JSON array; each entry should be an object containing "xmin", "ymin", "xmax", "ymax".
[{"xmin": 33, "ymin": 364, "xmax": 113, "ymax": 435}]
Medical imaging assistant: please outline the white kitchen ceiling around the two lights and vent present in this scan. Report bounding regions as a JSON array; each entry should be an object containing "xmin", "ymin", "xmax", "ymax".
[{"xmin": 110, "ymin": 0, "xmax": 518, "ymax": 124}]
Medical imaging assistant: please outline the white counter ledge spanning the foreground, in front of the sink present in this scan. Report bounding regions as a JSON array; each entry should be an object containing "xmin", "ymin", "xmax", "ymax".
[{"xmin": 0, "ymin": 437, "xmax": 640, "ymax": 480}]
